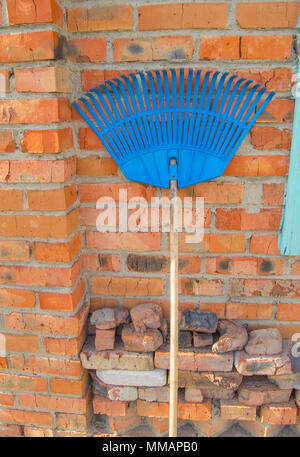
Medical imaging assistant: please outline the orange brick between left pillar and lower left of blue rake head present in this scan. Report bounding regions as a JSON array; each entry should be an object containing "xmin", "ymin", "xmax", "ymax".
[{"xmin": 77, "ymin": 155, "xmax": 119, "ymax": 176}]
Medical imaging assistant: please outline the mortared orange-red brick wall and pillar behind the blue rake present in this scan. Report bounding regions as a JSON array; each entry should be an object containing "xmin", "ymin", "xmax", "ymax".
[{"xmin": 0, "ymin": 0, "xmax": 300, "ymax": 436}]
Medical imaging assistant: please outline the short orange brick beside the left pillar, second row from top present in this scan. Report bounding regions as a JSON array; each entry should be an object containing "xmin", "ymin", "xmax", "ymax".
[{"xmin": 69, "ymin": 37, "xmax": 106, "ymax": 62}]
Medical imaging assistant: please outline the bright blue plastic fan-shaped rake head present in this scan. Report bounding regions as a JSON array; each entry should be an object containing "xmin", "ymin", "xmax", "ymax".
[{"xmin": 73, "ymin": 69, "xmax": 274, "ymax": 187}]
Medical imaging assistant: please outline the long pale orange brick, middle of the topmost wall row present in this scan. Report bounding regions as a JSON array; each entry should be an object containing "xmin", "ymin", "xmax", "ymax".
[{"xmin": 138, "ymin": 2, "xmax": 228, "ymax": 30}]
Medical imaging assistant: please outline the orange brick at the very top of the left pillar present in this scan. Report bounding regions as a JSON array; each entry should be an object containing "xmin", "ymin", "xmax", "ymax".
[{"xmin": 6, "ymin": 0, "xmax": 64, "ymax": 27}]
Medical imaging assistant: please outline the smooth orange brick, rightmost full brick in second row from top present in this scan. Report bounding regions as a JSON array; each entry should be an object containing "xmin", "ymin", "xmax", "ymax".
[{"xmin": 241, "ymin": 35, "xmax": 292, "ymax": 59}]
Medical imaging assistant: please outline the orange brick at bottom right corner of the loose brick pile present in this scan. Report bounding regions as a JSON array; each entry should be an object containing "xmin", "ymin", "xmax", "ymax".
[{"xmin": 260, "ymin": 401, "xmax": 297, "ymax": 425}]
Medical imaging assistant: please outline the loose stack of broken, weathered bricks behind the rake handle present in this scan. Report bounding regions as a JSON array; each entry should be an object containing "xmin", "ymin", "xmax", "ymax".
[{"xmin": 81, "ymin": 303, "xmax": 300, "ymax": 436}]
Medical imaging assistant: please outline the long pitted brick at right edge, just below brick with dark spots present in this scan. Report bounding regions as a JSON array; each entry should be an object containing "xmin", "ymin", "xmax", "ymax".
[{"xmin": 231, "ymin": 279, "xmax": 300, "ymax": 298}]
